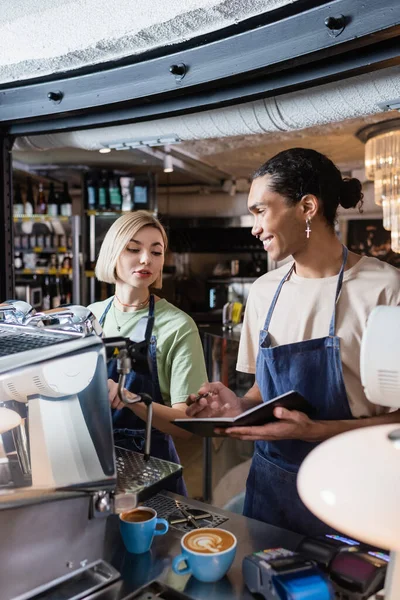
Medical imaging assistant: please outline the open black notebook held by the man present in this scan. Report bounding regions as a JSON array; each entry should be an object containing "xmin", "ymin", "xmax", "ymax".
[{"xmin": 171, "ymin": 390, "xmax": 313, "ymax": 437}]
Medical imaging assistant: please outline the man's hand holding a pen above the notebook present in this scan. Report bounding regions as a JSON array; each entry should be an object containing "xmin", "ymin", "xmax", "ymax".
[{"xmin": 186, "ymin": 381, "xmax": 243, "ymax": 418}]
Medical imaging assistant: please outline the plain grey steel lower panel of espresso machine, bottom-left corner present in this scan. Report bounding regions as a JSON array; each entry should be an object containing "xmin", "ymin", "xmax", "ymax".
[{"xmin": 0, "ymin": 492, "xmax": 107, "ymax": 600}]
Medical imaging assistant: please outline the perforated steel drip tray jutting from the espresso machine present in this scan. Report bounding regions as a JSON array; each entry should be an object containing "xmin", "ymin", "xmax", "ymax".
[{"xmin": 115, "ymin": 446, "xmax": 182, "ymax": 513}]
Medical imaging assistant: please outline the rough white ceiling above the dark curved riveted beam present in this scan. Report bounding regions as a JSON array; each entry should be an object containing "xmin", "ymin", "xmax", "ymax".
[{"xmin": 0, "ymin": 0, "xmax": 296, "ymax": 83}]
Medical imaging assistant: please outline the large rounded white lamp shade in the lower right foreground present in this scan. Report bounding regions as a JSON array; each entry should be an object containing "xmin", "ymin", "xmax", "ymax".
[{"xmin": 297, "ymin": 425, "xmax": 400, "ymax": 550}]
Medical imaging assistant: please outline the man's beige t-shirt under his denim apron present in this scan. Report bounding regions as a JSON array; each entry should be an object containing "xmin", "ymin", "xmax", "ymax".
[{"xmin": 236, "ymin": 257, "xmax": 400, "ymax": 417}]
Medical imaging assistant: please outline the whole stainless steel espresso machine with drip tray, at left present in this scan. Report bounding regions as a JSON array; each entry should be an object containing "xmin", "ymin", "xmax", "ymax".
[{"xmin": 0, "ymin": 300, "xmax": 181, "ymax": 600}]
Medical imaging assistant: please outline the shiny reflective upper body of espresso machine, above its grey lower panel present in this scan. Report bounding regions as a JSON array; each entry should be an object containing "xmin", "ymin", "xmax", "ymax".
[{"xmin": 0, "ymin": 318, "xmax": 116, "ymax": 492}]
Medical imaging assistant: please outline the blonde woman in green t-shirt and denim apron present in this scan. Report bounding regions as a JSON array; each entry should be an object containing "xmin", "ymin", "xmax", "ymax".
[{"xmin": 89, "ymin": 210, "xmax": 207, "ymax": 494}]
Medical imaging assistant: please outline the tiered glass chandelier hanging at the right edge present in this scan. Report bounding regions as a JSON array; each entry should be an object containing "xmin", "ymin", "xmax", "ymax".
[{"xmin": 357, "ymin": 119, "xmax": 400, "ymax": 253}]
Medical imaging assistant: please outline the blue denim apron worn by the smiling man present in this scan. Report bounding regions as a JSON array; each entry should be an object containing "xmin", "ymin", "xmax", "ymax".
[{"xmin": 243, "ymin": 246, "xmax": 353, "ymax": 535}]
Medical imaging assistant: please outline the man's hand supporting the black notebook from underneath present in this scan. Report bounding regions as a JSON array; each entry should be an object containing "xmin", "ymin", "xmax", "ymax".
[{"xmin": 219, "ymin": 406, "xmax": 320, "ymax": 442}]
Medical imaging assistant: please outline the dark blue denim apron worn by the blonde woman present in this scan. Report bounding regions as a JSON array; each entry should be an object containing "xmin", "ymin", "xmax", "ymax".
[{"xmin": 99, "ymin": 295, "xmax": 187, "ymax": 496}]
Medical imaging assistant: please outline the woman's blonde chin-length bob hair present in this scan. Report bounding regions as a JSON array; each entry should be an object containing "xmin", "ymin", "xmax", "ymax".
[{"xmin": 95, "ymin": 210, "xmax": 168, "ymax": 289}]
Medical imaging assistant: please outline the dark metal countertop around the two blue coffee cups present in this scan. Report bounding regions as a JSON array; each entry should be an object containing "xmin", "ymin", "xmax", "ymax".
[{"xmin": 101, "ymin": 492, "xmax": 302, "ymax": 600}]
